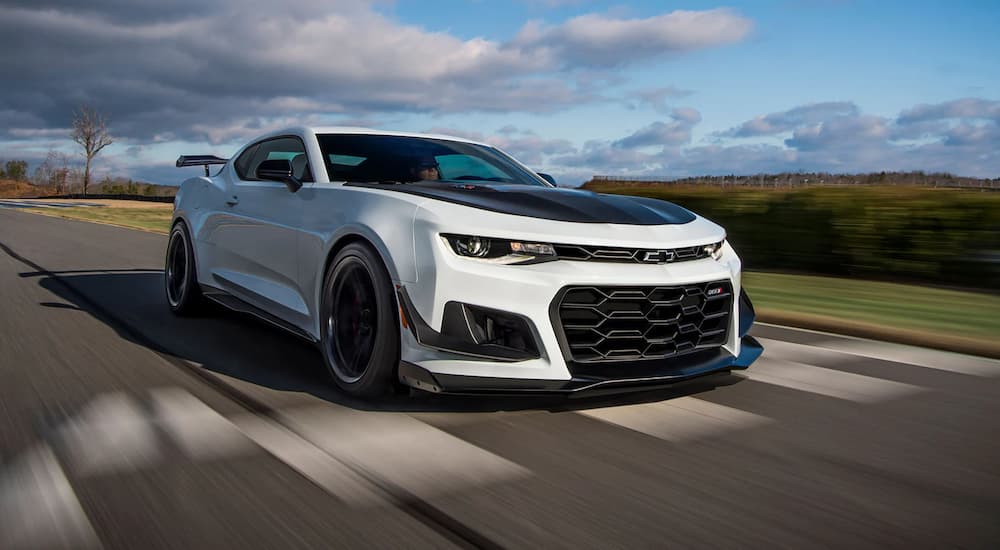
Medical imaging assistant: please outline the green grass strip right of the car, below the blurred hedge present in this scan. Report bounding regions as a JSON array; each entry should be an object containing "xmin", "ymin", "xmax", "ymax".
[{"xmin": 743, "ymin": 273, "xmax": 1000, "ymax": 341}]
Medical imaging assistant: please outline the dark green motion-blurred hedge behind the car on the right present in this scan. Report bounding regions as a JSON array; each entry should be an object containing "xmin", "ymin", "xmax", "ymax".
[{"xmin": 585, "ymin": 182, "xmax": 1000, "ymax": 291}]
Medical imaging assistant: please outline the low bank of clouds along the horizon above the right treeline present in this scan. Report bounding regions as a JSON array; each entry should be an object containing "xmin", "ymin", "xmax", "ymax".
[{"xmin": 532, "ymin": 99, "xmax": 1000, "ymax": 183}]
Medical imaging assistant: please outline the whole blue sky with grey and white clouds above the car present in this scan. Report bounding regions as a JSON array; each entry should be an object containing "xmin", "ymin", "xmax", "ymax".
[{"xmin": 0, "ymin": 0, "xmax": 1000, "ymax": 184}]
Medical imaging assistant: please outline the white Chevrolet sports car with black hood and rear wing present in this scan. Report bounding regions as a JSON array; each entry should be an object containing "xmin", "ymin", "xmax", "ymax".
[{"xmin": 164, "ymin": 128, "xmax": 762, "ymax": 396}]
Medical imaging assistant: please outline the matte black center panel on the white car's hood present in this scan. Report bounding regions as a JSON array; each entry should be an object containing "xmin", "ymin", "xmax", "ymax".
[{"xmin": 347, "ymin": 181, "xmax": 695, "ymax": 225}]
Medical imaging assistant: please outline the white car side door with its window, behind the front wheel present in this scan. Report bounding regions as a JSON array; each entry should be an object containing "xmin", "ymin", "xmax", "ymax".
[{"xmin": 206, "ymin": 136, "xmax": 313, "ymax": 325}]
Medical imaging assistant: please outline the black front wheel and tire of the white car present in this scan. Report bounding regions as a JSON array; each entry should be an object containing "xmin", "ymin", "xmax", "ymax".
[{"xmin": 320, "ymin": 243, "xmax": 399, "ymax": 397}]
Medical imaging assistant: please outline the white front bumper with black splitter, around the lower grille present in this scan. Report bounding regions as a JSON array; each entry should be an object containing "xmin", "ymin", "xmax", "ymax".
[{"xmin": 397, "ymin": 235, "xmax": 762, "ymax": 393}]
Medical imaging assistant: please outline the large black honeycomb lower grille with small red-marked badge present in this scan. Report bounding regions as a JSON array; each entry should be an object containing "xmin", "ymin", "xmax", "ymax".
[{"xmin": 557, "ymin": 281, "xmax": 733, "ymax": 363}]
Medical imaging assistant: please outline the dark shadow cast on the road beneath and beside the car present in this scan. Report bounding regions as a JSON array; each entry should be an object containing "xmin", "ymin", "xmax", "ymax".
[{"xmin": 29, "ymin": 269, "xmax": 743, "ymax": 412}]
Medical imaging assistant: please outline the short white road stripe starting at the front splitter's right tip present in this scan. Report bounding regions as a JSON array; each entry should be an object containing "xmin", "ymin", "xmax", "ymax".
[{"xmin": 745, "ymin": 357, "xmax": 926, "ymax": 403}]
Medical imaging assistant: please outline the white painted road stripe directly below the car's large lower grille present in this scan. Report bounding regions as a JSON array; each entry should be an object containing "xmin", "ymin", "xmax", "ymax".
[{"xmin": 577, "ymin": 397, "xmax": 773, "ymax": 442}]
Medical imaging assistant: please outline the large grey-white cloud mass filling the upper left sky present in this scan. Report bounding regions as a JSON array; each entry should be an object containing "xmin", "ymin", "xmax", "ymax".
[{"xmin": 0, "ymin": 0, "xmax": 751, "ymax": 142}]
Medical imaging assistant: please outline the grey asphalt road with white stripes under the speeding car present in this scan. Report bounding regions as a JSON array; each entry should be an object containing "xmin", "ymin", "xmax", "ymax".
[{"xmin": 0, "ymin": 209, "xmax": 1000, "ymax": 548}]
